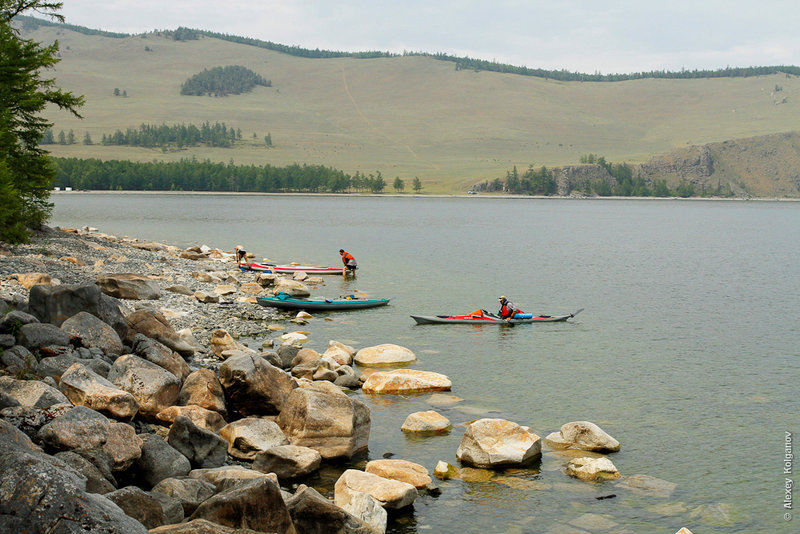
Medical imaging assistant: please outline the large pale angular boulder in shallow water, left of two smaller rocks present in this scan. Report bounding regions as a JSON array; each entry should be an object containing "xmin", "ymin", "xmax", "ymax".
[{"xmin": 456, "ymin": 418, "xmax": 542, "ymax": 468}]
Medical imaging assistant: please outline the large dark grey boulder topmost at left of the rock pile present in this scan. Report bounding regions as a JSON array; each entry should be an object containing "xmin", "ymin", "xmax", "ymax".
[{"xmin": 28, "ymin": 284, "xmax": 128, "ymax": 339}]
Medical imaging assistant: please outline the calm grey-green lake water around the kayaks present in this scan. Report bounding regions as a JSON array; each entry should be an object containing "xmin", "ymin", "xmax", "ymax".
[{"xmin": 52, "ymin": 193, "xmax": 800, "ymax": 534}]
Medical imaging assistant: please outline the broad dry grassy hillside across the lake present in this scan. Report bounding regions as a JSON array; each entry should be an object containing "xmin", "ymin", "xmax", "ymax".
[{"xmin": 24, "ymin": 26, "xmax": 800, "ymax": 193}]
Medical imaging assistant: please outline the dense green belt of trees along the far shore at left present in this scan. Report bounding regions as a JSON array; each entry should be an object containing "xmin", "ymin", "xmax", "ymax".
[{"xmin": 51, "ymin": 158, "xmax": 386, "ymax": 193}]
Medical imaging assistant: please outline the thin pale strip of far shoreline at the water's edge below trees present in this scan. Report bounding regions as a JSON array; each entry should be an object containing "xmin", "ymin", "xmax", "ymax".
[{"xmin": 50, "ymin": 189, "xmax": 800, "ymax": 202}]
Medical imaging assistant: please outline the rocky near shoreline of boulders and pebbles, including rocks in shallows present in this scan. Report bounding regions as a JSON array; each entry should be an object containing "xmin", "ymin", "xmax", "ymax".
[{"xmin": 0, "ymin": 228, "xmax": 692, "ymax": 533}]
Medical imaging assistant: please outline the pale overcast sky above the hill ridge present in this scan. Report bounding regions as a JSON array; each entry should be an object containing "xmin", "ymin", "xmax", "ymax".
[{"xmin": 56, "ymin": 0, "xmax": 800, "ymax": 74}]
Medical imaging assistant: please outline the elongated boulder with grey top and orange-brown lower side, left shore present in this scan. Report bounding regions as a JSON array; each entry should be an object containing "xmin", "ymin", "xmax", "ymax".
[{"xmin": 59, "ymin": 363, "xmax": 139, "ymax": 419}]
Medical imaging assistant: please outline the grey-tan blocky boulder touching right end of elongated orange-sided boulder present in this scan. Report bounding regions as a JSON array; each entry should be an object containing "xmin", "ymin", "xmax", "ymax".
[{"xmin": 106, "ymin": 354, "xmax": 181, "ymax": 419}]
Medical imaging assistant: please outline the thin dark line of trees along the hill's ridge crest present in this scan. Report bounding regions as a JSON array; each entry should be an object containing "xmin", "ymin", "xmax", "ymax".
[{"xmin": 17, "ymin": 16, "xmax": 800, "ymax": 82}]
